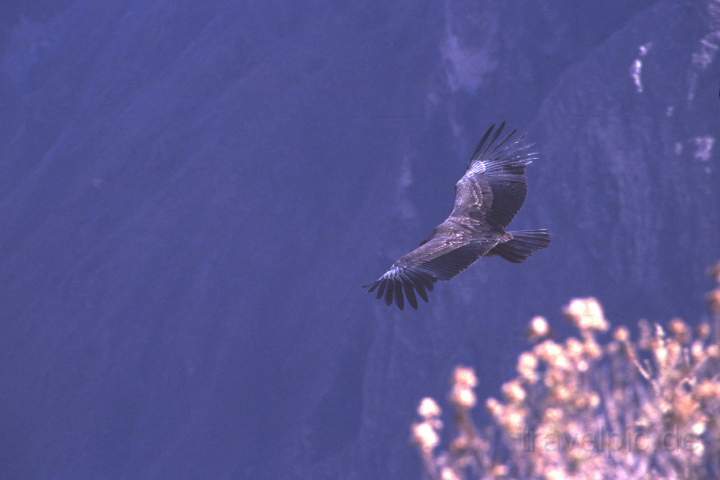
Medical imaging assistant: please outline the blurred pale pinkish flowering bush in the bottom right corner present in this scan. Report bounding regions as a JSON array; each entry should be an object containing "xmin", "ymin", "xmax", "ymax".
[{"xmin": 412, "ymin": 264, "xmax": 720, "ymax": 480}]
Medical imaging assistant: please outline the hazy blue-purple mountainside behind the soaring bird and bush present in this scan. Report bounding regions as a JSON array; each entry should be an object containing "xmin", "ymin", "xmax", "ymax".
[{"xmin": 0, "ymin": 0, "xmax": 720, "ymax": 480}]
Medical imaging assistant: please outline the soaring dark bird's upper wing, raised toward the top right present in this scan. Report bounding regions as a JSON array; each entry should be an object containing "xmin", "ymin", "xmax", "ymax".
[{"xmin": 450, "ymin": 122, "xmax": 538, "ymax": 227}]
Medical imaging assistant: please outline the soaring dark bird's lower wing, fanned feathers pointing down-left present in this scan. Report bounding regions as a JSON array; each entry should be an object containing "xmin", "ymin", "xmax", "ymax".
[{"xmin": 366, "ymin": 239, "xmax": 485, "ymax": 310}]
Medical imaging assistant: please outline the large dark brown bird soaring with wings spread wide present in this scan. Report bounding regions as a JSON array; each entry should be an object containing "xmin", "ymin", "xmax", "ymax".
[{"xmin": 365, "ymin": 122, "xmax": 550, "ymax": 310}]
